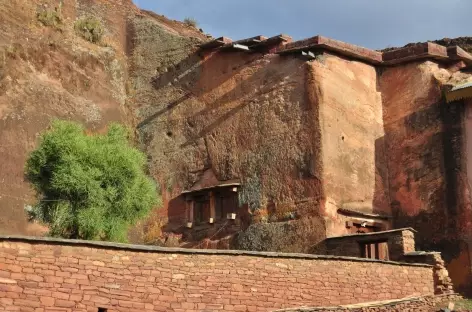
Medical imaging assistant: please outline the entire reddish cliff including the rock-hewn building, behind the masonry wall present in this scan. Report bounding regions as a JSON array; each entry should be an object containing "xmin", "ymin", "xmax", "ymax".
[{"xmin": 0, "ymin": 0, "xmax": 472, "ymax": 298}]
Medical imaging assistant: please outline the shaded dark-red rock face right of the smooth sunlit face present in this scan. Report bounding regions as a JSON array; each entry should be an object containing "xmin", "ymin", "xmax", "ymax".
[{"xmin": 380, "ymin": 63, "xmax": 445, "ymax": 215}]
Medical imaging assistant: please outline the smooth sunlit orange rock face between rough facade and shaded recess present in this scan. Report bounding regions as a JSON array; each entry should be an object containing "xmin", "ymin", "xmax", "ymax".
[{"xmin": 310, "ymin": 55, "xmax": 390, "ymax": 236}]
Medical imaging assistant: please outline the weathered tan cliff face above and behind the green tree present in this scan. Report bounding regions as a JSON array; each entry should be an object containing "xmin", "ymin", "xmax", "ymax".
[{"xmin": 0, "ymin": 0, "xmax": 205, "ymax": 234}]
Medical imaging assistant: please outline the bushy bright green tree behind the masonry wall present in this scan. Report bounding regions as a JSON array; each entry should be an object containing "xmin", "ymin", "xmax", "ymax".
[{"xmin": 26, "ymin": 121, "xmax": 159, "ymax": 242}]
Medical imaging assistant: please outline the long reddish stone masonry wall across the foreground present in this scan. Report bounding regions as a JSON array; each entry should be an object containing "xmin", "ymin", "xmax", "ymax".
[{"xmin": 0, "ymin": 237, "xmax": 434, "ymax": 312}]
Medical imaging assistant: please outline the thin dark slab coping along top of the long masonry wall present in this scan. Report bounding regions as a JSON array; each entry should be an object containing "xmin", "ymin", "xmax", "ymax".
[{"xmin": 0, "ymin": 235, "xmax": 433, "ymax": 268}]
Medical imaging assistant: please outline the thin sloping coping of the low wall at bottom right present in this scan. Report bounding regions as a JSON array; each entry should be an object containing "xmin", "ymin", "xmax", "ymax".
[{"xmin": 274, "ymin": 293, "xmax": 461, "ymax": 312}]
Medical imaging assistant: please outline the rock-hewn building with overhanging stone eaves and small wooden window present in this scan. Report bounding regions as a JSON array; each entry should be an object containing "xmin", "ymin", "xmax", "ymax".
[{"xmin": 146, "ymin": 35, "xmax": 472, "ymax": 289}]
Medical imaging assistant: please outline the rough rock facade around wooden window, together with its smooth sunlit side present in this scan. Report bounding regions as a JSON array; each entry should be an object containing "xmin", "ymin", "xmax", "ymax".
[{"xmin": 138, "ymin": 43, "xmax": 390, "ymax": 244}]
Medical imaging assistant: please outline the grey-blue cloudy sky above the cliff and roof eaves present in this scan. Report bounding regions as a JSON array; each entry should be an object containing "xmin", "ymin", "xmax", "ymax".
[{"xmin": 134, "ymin": 0, "xmax": 472, "ymax": 49}]
